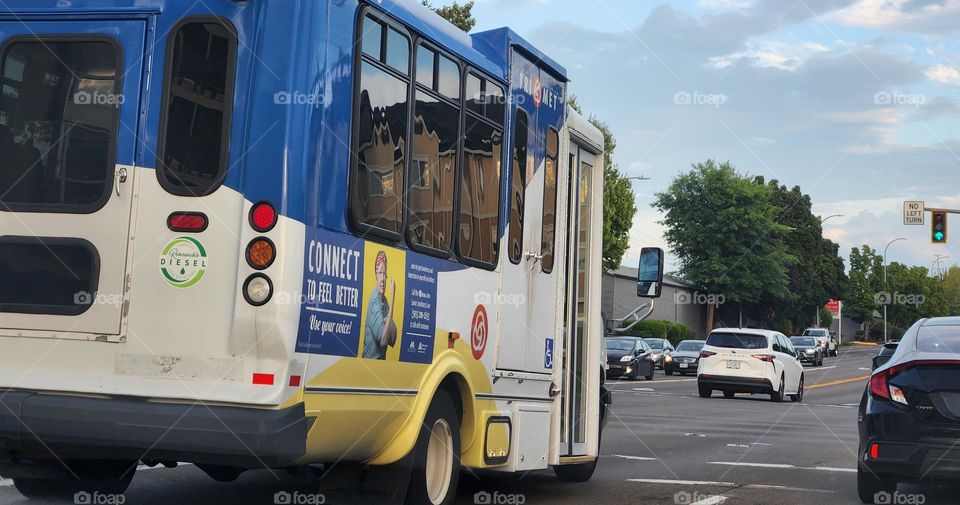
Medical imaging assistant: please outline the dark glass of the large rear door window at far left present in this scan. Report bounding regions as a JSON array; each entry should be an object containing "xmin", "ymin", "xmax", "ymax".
[{"xmin": 0, "ymin": 39, "xmax": 123, "ymax": 212}]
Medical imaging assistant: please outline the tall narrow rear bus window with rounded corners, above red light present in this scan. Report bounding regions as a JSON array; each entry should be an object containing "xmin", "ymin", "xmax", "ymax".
[{"xmin": 157, "ymin": 18, "xmax": 237, "ymax": 196}]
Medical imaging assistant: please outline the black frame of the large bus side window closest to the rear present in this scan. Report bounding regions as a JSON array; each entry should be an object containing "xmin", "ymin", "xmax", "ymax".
[{"xmin": 347, "ymin": 7, "xmax": 416, "ymax": 242}]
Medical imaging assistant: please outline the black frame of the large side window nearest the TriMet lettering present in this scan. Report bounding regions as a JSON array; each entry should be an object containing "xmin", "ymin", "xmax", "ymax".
[{"xmin": 454, "ymin": 63, "xmax": 508, "ymax": 270}]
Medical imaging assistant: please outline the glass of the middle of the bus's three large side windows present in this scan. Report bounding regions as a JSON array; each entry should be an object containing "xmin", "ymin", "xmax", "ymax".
[{"xmin": 407, "ymin": 45, "xmax": 460, "ymax": 252}]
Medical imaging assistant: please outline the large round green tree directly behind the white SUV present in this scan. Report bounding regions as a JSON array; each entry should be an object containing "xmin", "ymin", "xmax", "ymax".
[{"xmin": 653, "ymin": 160, "xmax": 796, "ymax": 331}]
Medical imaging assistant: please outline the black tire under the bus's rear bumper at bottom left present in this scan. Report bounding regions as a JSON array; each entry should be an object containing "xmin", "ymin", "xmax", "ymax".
[{"xmin": 13, "ymin": 461, "xmax": 137, "ymax": 499}]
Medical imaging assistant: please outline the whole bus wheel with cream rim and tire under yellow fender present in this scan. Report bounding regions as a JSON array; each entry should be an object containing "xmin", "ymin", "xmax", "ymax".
[{"xmin": 406, "ymin": 389, "xmax": 460, "ymax": 505}]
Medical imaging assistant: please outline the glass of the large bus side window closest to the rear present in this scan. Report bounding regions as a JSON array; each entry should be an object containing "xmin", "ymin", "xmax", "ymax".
[{"xmin": 350, "ymin": 16, "xmax": 410, "ymax": 240}]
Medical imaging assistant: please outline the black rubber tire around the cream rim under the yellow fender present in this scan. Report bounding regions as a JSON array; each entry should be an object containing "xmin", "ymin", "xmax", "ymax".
[{"xmin": 405, "ymin": 389, "xmax": 460, "ymax": 505}]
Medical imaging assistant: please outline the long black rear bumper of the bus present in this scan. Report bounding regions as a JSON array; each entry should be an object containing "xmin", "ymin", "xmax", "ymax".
[{"xmin": 0, "ymin": 391, "xmax": 309, "ymax": 468}]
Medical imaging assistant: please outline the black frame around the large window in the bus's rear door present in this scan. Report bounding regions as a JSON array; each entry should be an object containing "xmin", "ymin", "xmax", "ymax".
[{"xmin": 0, "ymin": 34, "xmax": 127, "ymax": 214}]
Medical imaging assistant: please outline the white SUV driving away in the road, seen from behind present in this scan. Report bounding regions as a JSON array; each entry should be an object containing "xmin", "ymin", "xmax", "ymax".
[{"xmin": 697, "ymin": 328, "xmax": 803, "ymax": 402}]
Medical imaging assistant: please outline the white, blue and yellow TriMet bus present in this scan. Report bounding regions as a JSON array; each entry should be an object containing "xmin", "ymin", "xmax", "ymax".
[{"xmin": 0, "ymin": 0, "xmax": 660, "ymax": 504}]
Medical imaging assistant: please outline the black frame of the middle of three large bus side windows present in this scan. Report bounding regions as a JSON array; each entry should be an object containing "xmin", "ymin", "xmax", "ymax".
[{"xmin": 403, "ymin": 36, "xmax": 466, "ymax": 259}]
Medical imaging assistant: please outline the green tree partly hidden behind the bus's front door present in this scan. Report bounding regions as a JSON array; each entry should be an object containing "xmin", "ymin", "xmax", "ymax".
[{"xmin": 569, "ymin": 96, "xmax": 637, "ymax": 271}]
